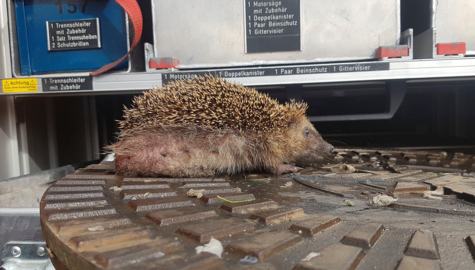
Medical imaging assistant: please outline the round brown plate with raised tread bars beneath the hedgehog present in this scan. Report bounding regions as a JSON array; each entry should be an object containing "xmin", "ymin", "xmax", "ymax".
[{"xmin": 40, "ymin": 149, "xmax": 475, "ymax": 270}]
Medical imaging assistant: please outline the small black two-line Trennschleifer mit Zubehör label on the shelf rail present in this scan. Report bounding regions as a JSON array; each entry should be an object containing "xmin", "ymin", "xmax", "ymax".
[{"xmin": 41, "ymin": 76, "xmax": 92, "ymax": 92}]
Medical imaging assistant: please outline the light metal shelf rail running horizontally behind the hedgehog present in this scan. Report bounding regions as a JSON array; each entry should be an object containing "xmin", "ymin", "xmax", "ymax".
[{"xmin": 0, "ymin": 58, "xmax": 475, "ymax": 95}]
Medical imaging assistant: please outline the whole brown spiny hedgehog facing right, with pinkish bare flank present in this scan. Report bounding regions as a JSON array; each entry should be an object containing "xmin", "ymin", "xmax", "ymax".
[{"xmin": 109, "ymin": 75, "xmax": 333, "ymax": 177}]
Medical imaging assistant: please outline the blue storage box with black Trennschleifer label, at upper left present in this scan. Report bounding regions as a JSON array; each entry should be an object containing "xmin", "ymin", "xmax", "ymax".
[{"xmin": 13, "ymin": 0, "xmax": 129, "ymax": 76}]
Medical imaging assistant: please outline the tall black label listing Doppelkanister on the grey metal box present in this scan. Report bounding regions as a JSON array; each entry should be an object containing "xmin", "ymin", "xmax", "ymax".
[{"xmin": 245, "ymin": 0, "xmax": 300, "ymax": 53}]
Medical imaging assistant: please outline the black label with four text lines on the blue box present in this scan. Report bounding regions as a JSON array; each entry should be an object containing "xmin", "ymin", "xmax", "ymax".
[{"xmin": 46, "ymin": 18, "xmax": 101, "ymax": 51}]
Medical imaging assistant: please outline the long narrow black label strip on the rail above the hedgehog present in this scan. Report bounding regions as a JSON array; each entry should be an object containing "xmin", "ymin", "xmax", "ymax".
[{"xmin": 162, "ymin": 62, "xmax": 389, "ymax": 85}]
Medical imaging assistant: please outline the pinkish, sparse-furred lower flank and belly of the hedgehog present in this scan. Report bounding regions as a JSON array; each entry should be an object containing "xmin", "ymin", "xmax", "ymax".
[{"xmin": 111, "ymin": 128, "xmax": 282, "ymax": 177}]
